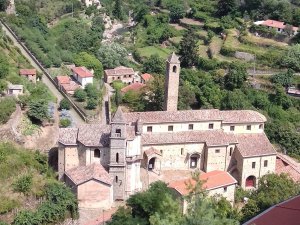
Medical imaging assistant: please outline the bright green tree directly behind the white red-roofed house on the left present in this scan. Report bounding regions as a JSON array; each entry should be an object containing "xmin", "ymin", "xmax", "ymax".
[{"xmin": 74, "ymin": 52, "xmax": 103, "ymax": 79}]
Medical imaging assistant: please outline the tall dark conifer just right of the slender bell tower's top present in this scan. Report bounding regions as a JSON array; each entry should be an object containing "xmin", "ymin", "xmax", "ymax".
[{"xmin": 179, "ymin": 29, "xmax": 198, "ymax": 67}]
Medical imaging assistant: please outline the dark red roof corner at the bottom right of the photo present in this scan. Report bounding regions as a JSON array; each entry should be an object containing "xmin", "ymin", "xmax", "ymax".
[{"xmin": 244, "ymin": 195, "xmax": 300, "ymax": 225}]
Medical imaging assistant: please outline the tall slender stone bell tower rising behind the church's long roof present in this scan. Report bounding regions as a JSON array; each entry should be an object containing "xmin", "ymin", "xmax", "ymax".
[{"xmin": 164, "ymin": 52, "xmax": 180, "ymax": 111}]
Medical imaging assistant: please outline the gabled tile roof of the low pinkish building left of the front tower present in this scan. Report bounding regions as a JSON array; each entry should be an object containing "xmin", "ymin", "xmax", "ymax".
[{"xmin": 65, "ymin": 163, "xmax": 112, "ymax": 185}]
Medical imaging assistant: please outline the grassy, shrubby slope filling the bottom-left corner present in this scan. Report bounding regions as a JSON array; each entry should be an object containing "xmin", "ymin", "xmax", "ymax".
[{"xmin": 0, "ymin": 143, "xmax": 77, "ymax": 225}]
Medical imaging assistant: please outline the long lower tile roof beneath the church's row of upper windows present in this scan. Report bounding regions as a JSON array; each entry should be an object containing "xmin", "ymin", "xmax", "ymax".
[{"xmin": 142, "ymin": 130, "xmax": 237, "ymax": 146}]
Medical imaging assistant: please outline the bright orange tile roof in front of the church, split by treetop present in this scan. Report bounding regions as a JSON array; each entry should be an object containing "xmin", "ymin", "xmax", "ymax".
[{"xmin": 168, "ymin": 170, "xmax": 237, "ymax": 196}]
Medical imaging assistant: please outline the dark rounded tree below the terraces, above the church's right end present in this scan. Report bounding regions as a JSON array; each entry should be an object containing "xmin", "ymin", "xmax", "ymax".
[{"xmin": 224, "ymin": 63, "xmax": 248, "ymax": 90}]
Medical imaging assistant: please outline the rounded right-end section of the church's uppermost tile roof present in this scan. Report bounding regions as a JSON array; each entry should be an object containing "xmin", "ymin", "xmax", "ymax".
[{"xmin": 220, "ymin": 110, "xmax": 267, "ymax": 123}]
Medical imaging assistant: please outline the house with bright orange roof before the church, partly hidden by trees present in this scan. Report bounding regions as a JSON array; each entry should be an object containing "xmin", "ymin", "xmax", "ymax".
[{"xmin": 168, "ymin": 170, "xmax": 237, "ymax": 213}]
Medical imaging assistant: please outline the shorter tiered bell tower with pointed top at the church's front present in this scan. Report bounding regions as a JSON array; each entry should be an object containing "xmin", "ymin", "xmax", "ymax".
[{"xmin": 109, "ymin": 107, "xmax": 126, "ymax": 200}]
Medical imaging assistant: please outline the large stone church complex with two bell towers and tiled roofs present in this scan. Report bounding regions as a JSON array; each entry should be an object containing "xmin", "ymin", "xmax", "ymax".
[{"xmin": 58, "ymin": 53, "xmax": 276, "ymax": 208}]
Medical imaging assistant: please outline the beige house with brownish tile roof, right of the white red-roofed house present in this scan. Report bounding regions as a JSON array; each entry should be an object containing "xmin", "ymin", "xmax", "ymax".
[{"xmin": 104, "ymin": 66, "xmax": 135, "ymax": 84}]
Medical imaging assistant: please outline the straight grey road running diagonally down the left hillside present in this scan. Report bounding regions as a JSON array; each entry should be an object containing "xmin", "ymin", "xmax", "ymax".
[{"xmin": 1, "ymin": 23, "xmax": 84, "ymax": 125}]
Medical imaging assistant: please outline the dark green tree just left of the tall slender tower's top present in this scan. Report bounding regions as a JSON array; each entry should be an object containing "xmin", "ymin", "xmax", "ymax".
[{"xmin": 143, "ymin": 54, "xmax": 165, "ymax": 74}]
